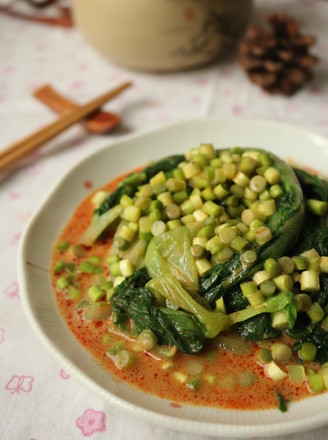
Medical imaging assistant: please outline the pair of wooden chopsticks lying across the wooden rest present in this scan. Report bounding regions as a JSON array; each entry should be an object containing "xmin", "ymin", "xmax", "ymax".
[{"xmin": 0, "ymin": 82, "xmax": 132, "ymax": 173}]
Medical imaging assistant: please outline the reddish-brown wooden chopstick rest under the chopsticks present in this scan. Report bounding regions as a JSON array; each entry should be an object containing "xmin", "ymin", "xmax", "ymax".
[{"xmin": 33, "ymin": 84, "xmax": 121, "ymax": 134}]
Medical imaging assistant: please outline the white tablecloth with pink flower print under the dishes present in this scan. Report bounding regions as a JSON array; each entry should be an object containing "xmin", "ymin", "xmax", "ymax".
[{"xmin": 0, "ymin": 0, "xmax": 328, "ymax": 440}]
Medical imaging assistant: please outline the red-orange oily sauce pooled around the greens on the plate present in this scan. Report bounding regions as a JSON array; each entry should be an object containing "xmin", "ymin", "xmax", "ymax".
[{"xmin": 52, "ymin": 171, "xmax": 316, "ymax": 410}]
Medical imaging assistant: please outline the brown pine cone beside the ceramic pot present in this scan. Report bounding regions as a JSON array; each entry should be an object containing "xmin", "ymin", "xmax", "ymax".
[{"xmin": 239, "ymin": 13, "xmax": 318, "ymax": 96}]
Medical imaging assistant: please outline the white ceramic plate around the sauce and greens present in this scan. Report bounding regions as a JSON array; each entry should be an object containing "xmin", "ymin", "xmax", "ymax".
[{"xmin": 19, "ymin": 119, "xmax": 328, "ymax": 437}]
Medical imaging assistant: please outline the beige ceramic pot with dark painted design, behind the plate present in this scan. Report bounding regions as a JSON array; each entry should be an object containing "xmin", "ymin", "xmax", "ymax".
[{"xmin": 73, "ymin": 0, "xmax": 252, "ymax": 71}]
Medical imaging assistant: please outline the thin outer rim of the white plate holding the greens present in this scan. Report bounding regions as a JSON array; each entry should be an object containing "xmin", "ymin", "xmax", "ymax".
[{"xmin": 17, "ymin": 117, "xmax": 328, "ymax": 438}]
